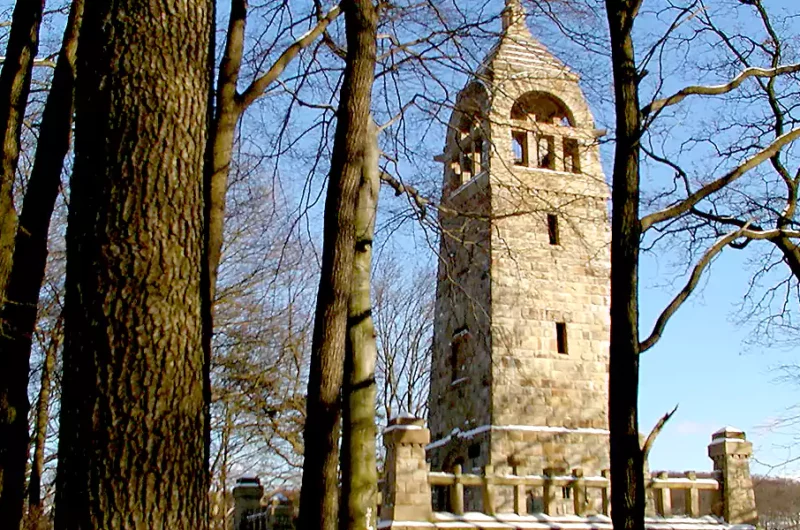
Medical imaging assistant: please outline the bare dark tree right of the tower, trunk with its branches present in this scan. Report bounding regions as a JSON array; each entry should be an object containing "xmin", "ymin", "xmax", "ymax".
[{"xmin": 606, "ymin": 0, "xmax": 800, "ymax": 528}]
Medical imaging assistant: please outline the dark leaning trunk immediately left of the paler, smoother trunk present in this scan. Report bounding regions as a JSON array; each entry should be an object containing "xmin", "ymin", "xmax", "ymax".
[{"xmin": 300, "ymin": 0, "xmax": 378, "ymax": 530}]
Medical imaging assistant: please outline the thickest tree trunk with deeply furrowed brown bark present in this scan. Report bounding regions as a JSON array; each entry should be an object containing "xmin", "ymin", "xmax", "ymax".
[{"xmin": 55, "ymin": 0, "xmax": 214, "ymax": 530}]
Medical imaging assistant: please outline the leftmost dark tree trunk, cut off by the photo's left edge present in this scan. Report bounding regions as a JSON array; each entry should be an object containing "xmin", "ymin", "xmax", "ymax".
[{"xmin": 0, "ymin": 0, "xmax": 44, "ymax": 306}]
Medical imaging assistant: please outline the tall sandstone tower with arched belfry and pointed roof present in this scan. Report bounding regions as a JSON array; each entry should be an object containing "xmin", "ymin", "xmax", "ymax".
[{"xmin": 428, "ymin": 0, "xmax": 610, "ymax": 486}]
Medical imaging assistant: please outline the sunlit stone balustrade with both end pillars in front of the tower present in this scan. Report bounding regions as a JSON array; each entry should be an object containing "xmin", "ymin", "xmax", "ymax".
[{"xmin": 381, "ymin": 418, "xmax": 757, "ymax": 528}]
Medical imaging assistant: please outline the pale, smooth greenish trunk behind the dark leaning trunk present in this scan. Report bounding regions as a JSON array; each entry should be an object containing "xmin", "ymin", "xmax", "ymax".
[{"xmin": 339, "ymin": 117, "xmax": 380, "ymax": 530}]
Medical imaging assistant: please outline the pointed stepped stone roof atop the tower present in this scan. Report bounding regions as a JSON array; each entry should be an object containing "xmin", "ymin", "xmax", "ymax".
[{"xmin": 478, "ymin": 0, "xmax": 575, "ymax": 77}]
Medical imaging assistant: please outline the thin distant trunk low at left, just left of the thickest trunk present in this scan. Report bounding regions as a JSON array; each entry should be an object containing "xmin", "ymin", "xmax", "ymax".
[{"xmin": 26, "ymin": 315, "xmax": 63, "ymax": 528}]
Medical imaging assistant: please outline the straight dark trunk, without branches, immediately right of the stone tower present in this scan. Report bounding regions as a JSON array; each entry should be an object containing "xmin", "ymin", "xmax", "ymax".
[{"xmin": 606, "ymin": 0, "xmax": 645, "ymax": 530}]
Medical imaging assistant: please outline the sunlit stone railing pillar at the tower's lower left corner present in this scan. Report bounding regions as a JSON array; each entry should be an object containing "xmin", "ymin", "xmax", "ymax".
[{"xmin": 380, "ymin": 418, "xmax": 432, "ymax": 522}]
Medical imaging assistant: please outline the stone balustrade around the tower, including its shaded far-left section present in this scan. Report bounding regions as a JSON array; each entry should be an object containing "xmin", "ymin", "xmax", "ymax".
[{"xmin": 233, "ymin": 418, "xmax": 757, "ymax": 530}]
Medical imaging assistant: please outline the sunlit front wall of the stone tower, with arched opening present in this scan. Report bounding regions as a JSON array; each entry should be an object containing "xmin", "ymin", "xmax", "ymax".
[{"xmin": 490, "ymin": 32, "xmax": 610, "ymax": 474}]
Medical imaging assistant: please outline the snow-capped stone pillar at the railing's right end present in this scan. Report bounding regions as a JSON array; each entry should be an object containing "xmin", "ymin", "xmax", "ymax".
[{"xmin": 708, "ymin": 427, "xmax": 758, "ymax": 525}]
